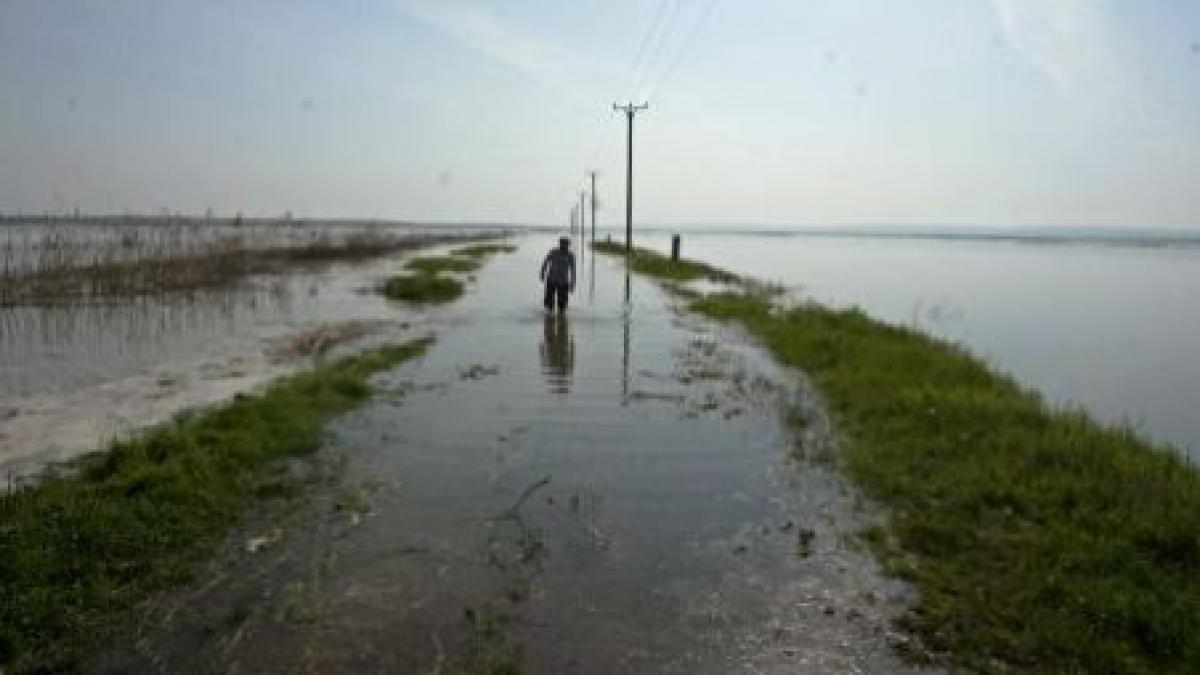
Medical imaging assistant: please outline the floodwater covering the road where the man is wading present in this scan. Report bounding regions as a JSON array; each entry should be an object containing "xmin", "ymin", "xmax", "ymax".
[{"xmin": 102, "ymin": 239, "xmax": 931, "ymax": 674}]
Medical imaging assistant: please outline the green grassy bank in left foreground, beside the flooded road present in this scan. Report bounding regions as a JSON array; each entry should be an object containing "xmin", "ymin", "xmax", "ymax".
[{"xmin": 0, "ymin": 340, "xmax": 430, "ymax": 673}]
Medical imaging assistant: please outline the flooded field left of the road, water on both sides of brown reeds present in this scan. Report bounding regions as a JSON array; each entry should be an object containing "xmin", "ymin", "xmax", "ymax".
[{"xmin": 0, "ymin": 220, "xmax": 494, "ymax": 474}]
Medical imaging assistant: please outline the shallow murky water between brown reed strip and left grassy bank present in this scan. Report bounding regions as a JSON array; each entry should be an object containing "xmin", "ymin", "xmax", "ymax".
[{"xmin": 0, "ymin": 254, "xmax": 420, "ymax": 474}]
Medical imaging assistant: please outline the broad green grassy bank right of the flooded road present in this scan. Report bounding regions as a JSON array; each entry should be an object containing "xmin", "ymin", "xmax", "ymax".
[{"xmin": 600, "ymin": 241, "xmax": 1200, "ymax": 673}]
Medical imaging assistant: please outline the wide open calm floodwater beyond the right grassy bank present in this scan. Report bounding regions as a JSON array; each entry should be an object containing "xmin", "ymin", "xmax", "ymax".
[{"xmin": 643, "ymin": 231, "xmax": 1200, "ymax": 460}]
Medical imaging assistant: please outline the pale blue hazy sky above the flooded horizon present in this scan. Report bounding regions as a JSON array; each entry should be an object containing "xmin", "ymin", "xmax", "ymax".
[{"xmin": 0, "ymin": 0, "xmax": 1200, "ymax": 227}]
